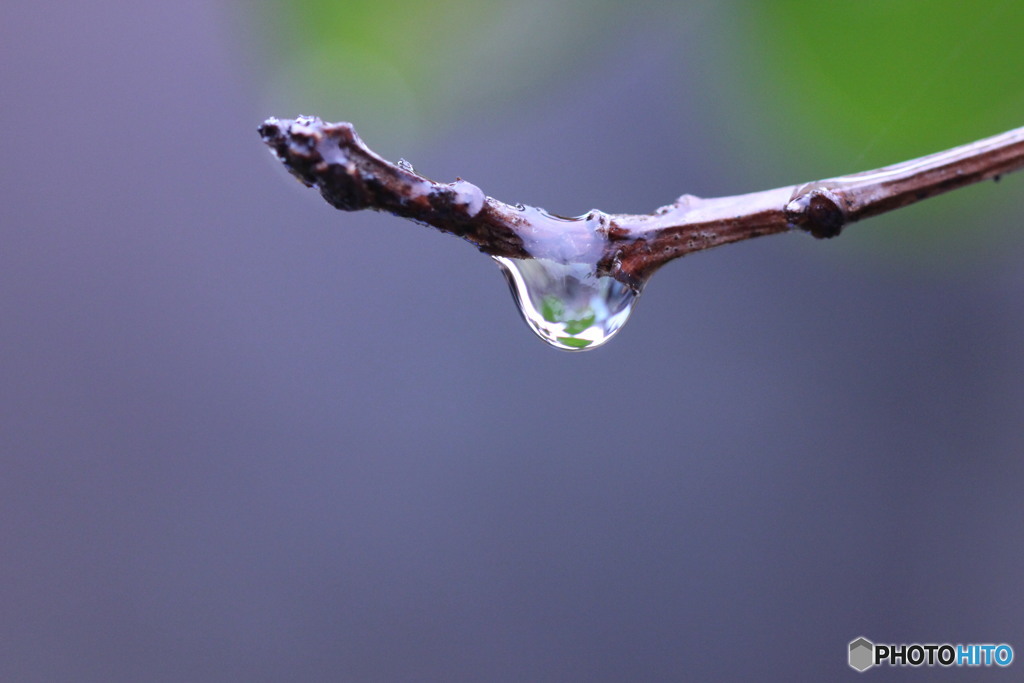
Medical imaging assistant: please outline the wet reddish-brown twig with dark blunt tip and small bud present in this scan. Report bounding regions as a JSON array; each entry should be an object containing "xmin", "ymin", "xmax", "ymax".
[{"xmin": 259, "ymin": 117, "xmax": 1024, "ymax": 285}]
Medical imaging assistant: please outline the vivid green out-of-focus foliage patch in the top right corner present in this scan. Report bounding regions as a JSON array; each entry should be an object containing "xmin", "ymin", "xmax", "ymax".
[{"xmin": 737, "ymin": 0, "xmax": 1024, "ymax": 165}]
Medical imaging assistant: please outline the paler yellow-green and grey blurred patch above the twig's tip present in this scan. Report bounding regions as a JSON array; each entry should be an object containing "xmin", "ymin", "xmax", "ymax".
[{"xmin": 271, "ymin": 0, "xmax": 621, "ymax": 143}]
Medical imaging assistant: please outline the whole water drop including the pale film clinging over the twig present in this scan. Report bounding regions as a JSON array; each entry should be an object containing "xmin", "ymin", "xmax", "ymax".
[{"xmin": 494, "ymin": 207, "xmax": 642, "ymax": 351}]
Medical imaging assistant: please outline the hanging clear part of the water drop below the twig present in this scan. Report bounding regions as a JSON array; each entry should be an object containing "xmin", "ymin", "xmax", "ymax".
[{"xmin": 494, "ymin": 256, "xmax": 640, "ymax": 351}]
